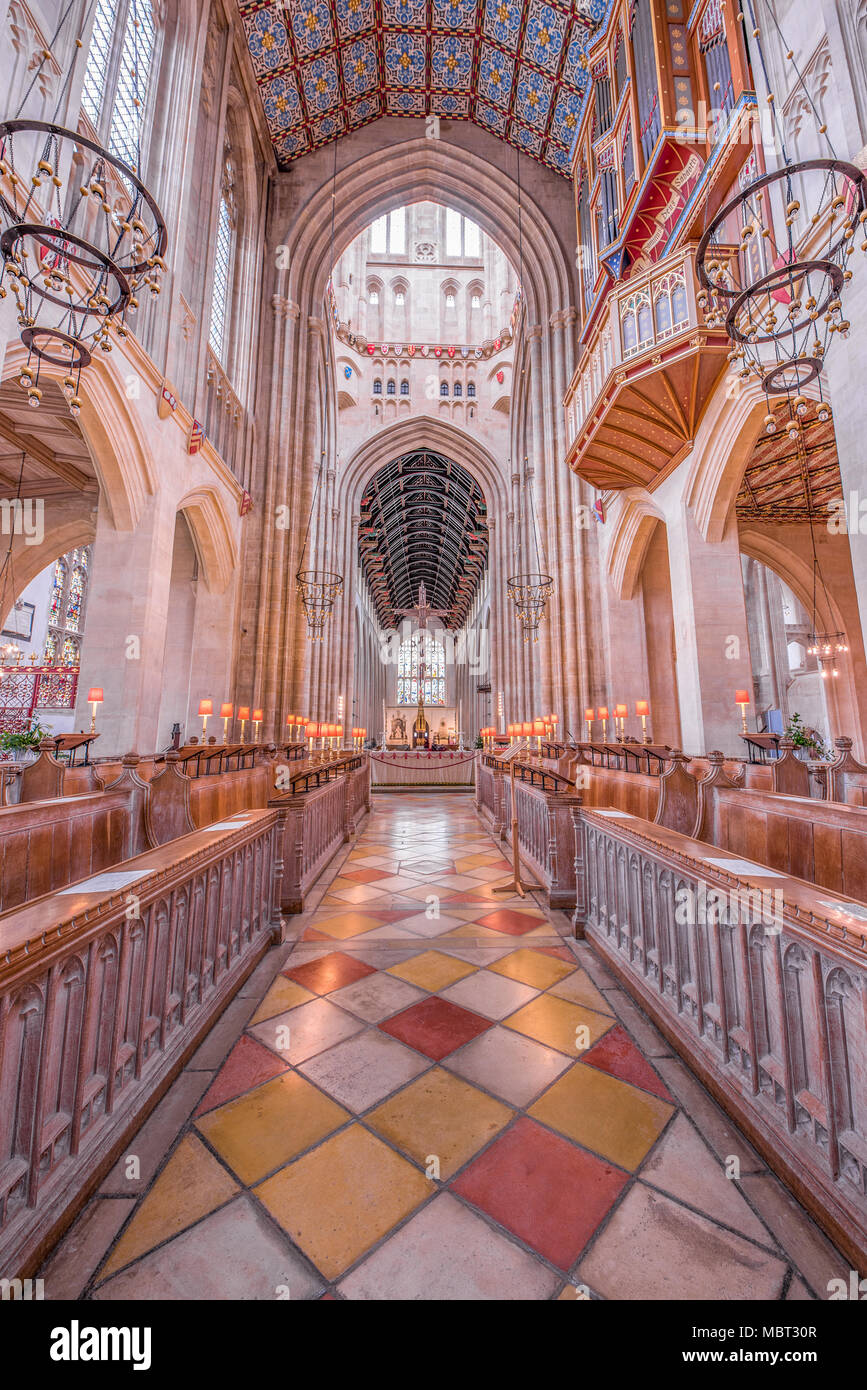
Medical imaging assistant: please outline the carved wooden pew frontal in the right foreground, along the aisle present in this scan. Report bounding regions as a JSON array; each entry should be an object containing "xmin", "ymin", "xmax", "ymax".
[{"xmin": 578, "ymin": 811, "xmax": 867, "ymax": 1269}]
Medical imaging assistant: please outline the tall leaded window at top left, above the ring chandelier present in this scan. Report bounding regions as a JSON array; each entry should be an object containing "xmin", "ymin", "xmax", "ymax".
[{"xmin": 82, "ymin": 0, "xmax": 156, "ymax": 168}]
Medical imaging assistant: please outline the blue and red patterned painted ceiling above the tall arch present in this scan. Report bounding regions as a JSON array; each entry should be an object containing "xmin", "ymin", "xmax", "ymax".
[{"xmin": 238, "ymin": 0, "xmax": 611, "ymax": 177}]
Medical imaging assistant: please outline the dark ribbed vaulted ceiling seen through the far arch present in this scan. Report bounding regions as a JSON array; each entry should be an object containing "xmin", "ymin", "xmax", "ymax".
[{"xmin": 358, "ymin": 449, "xmax": 488, "ymax": 628}]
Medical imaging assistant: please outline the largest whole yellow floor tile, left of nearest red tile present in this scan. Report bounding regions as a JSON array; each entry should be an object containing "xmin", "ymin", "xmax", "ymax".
[{"xmin": 256, "ymin": 1125, "xmax": 434, "ymax": 1279}]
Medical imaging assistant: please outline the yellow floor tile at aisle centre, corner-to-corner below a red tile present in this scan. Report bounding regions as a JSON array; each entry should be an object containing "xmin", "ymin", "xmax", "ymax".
[{"xmin": 365, "ymin": 1068, "xmax": 514, "ymax": 1179}]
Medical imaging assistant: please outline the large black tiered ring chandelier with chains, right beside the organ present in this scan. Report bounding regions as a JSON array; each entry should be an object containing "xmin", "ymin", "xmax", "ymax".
[{"xmin": 696, "ymin": 0, "xmax": 867, "ymax": 436}]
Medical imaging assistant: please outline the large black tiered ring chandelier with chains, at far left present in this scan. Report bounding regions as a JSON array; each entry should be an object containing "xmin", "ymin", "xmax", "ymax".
[{"xmin": 0, "ymin": 0, "xmax": 168, "ymax": 416}]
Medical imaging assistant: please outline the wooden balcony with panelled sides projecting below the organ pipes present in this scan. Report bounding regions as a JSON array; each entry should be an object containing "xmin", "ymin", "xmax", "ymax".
[{"xmin": 564, "ymin": 246, "xmax": 729, "ymax": 489}]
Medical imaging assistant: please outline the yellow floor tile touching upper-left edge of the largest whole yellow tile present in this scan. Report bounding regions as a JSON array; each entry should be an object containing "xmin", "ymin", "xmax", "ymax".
[{"xmin": 196, "ymin": 1072, "xmax": 349, "ymax": 1183}]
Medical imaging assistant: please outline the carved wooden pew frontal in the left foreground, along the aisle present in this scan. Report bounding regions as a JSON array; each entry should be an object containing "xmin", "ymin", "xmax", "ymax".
[{"xmin": 0, "ymin": 811, "xmax": 282, "ymax": 1277}]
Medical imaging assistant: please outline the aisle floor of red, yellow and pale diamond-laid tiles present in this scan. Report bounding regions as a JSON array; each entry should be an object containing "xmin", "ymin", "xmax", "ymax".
[{"xmin": 42, "ymin": 792, "xmax": 846, "ymax": 1300}]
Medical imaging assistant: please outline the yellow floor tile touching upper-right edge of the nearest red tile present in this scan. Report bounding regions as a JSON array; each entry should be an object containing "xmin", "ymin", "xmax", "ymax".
[{"xmin": 528, "ymin": 1062, "xmax": 674, "ymax": 1169}]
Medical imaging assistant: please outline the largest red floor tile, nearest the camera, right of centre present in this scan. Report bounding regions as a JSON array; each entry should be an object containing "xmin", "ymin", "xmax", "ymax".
[{"xmin": 453, "ymin": 1116, "xmax": 629, "ymax": 1269}]
